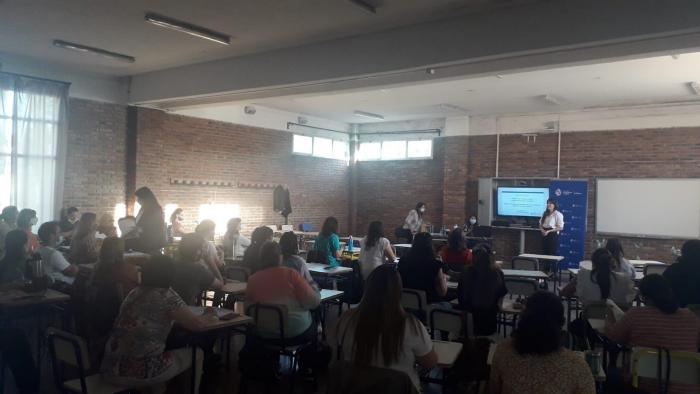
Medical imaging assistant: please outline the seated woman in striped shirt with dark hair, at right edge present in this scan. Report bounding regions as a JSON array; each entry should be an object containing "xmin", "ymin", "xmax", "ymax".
[{"xmin": 605, "ymin": 274, "xmax": 700, "ymax": 393}]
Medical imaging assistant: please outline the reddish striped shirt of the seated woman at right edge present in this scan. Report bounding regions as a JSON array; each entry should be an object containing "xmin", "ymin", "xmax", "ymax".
[{"xmin": 605, "ymin": 307, "xmax": 700, "ymax": 394}]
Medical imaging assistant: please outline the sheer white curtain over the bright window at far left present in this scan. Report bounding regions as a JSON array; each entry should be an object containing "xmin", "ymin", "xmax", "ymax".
[{"xmin": 0, "ymin": 72, "xmax": 69, "ymax": 223}]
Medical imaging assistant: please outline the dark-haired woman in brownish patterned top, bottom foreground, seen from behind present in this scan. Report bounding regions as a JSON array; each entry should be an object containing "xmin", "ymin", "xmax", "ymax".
[{"xmin": 489, "ymin": 291, "xmax": 596, "ymax": 394}]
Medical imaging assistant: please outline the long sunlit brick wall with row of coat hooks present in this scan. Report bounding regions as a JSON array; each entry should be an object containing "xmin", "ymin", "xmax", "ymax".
[{"xmin": 136, "ymin": 109, "xmax": 349, "ymax": 233}]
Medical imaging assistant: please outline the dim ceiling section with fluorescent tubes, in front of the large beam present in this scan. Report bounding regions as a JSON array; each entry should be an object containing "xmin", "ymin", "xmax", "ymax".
[{"xmin": 0, "ymin": 0, "xmax": 533, "ymax": 76}]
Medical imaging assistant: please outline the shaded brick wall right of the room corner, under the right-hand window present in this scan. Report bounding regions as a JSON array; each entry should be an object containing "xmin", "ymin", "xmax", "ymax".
[{"xmin": 354, "ymin": 139, "xmax": 444, "ymax": 239}]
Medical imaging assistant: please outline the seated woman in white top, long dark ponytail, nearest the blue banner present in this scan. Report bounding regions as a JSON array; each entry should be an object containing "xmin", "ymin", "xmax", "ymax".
[{"xmin": 561, "ymin": 248, "xmax": 636, "ymax": 308}]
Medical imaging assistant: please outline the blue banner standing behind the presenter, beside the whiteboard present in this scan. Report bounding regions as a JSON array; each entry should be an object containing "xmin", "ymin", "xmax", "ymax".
[{"xmin": 549, "ymin": 179, "xmax": 588, "ymax": 270}]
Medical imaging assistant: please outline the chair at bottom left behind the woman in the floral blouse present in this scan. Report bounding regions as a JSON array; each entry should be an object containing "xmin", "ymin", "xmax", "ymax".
[{"xmin": 47, "ymin": 327, "xmax": 131, "ymax": 394}]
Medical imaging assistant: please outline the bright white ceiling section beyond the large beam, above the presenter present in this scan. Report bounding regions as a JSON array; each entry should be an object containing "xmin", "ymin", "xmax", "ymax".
[{"xmin": 234, "ymin": 53, "xmax": 700, "ymax": 123}]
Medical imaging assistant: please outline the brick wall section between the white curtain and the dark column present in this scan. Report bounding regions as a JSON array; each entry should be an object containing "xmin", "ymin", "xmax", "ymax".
[{"xmin": 63, "ymin": 98, "xmax": 126, "ymax": 220}]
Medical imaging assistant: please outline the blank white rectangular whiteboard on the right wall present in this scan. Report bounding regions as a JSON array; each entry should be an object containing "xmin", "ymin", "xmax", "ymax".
[{"xmin": 595, "ymin": 179, "xmax": 700, "ymax": 238}]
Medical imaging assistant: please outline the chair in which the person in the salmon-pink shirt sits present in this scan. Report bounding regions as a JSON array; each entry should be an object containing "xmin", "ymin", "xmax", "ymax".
[{"xmin": 241, "ymin": 303, "xmax": 311, "ymax": 393}]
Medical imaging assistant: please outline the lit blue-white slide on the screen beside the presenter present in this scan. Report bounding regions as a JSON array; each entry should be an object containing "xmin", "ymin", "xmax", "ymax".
[{"xmin": 498, "ymin": 187, "xmax": 549, "ymax": 217}]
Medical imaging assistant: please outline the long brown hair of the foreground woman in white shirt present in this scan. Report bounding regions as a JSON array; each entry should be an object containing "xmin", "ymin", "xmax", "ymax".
[{"xmin": 338, "ymin": 265, "xmax": 419, "ymax": 366}]
